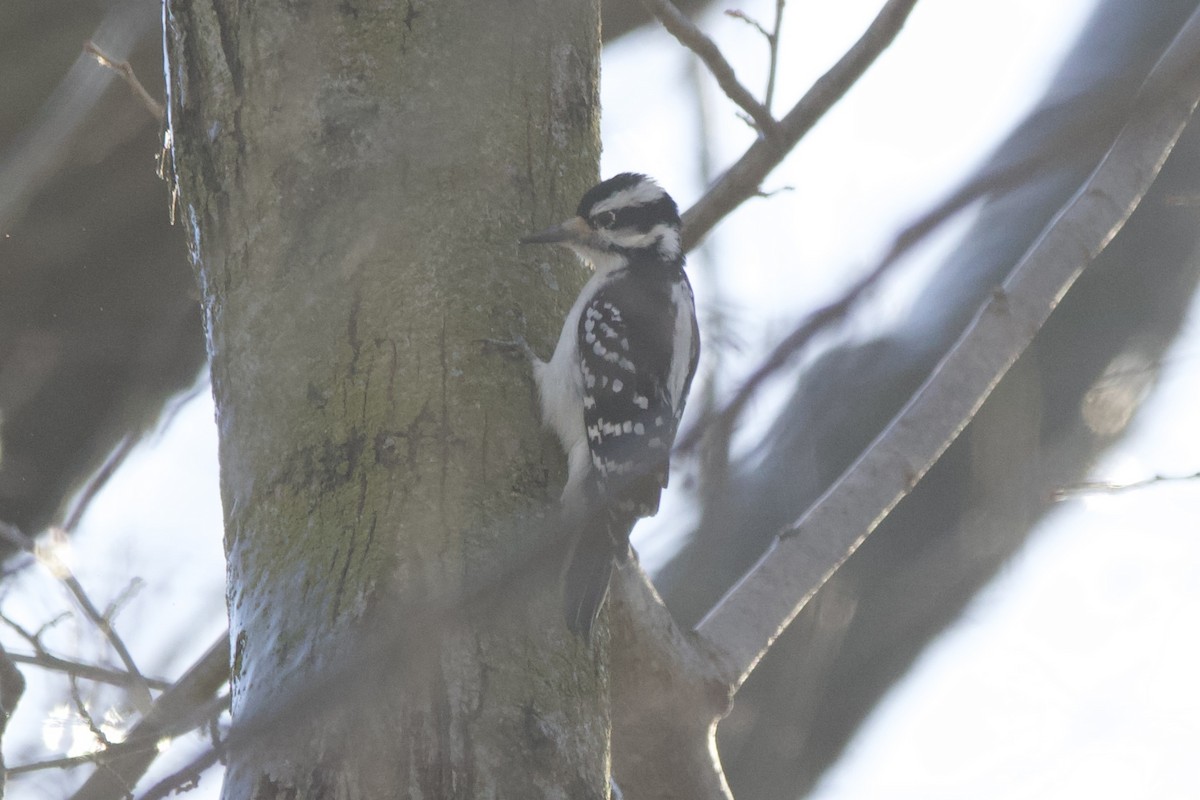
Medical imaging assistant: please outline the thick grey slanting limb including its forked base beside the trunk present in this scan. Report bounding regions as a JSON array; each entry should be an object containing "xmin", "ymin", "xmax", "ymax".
[{"xmin": 612, "ymin": 6, "xmax": 1200, "ymax": 800}]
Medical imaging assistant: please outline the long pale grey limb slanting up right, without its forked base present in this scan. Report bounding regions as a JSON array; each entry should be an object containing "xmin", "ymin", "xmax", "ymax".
[{"xmin": 697, "ymin": 12, "xmax": 1200, "ymax": 687}]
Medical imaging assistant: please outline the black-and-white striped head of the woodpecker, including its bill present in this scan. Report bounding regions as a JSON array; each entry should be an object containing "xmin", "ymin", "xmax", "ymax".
[{"xmin": 521, "ymin": 173, "xmax": 683, "ymax": 271}]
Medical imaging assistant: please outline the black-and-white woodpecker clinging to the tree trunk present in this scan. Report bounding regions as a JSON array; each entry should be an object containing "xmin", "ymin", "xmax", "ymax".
[{"xmin": 521, "ymin": 173, "xmax": 700, "ymax": 638}]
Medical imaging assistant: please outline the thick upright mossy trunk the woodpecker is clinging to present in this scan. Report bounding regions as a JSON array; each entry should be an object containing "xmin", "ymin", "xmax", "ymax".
[{"xmin": 164, "ymin": 0, "xmax": 608, "ymax": 800}]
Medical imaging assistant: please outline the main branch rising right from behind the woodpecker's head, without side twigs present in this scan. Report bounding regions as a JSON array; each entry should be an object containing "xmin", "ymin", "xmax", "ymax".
[{"xmin": 676, "ymin": 0, "xmax": 917, "ymax": 251}]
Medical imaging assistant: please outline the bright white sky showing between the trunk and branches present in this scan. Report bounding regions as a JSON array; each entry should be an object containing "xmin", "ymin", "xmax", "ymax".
[{"xmin": 2, "ymin": 0, "xmax": 1200, "ymax": 800}]
